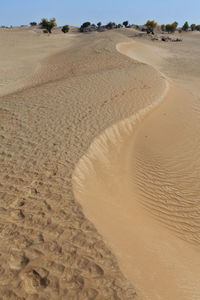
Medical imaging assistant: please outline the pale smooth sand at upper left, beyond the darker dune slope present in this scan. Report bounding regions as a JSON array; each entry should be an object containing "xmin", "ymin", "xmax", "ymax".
[{"xmin": 0, "ymin": 27, "xmax": 78, "ymax": 96}]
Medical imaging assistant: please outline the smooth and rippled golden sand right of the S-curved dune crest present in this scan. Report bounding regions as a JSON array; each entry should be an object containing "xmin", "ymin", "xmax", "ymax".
[{"xmin": 74, "ymin": 34, "xmax": 200, "ymax": 300}]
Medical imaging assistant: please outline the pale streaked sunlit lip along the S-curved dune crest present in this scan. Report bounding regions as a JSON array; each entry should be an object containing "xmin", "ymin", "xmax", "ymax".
[{"xmin": 73, "ymin": 42, "xmax": 170, "ymax": 194}]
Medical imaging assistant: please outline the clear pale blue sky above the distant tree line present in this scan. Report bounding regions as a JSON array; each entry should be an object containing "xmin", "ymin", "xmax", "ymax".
[{"xmin": 0, "ymin": 0, "xmax": 200, "ymax": 26}]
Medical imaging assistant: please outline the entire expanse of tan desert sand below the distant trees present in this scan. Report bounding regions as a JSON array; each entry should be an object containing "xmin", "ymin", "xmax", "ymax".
[{"xmin": 0, "ymin": 28, "xmax": 200, "ymax": 300}]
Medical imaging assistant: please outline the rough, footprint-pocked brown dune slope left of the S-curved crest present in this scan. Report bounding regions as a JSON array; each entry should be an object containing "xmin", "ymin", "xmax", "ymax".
[{"xmin": 0, "ymin": 32, "xmax": 165, "ymax": 300}]
